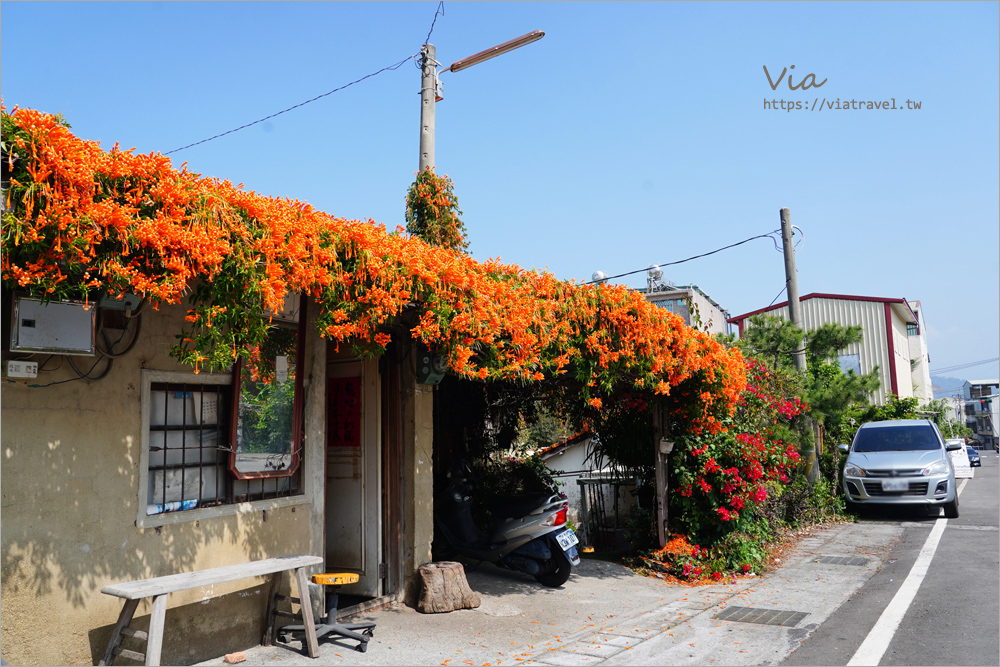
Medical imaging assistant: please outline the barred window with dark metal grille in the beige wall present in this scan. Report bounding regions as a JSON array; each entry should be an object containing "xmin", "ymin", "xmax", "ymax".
[{"xmin": 146, "ymin": 382, "xmax": 301, "ymax": 516}]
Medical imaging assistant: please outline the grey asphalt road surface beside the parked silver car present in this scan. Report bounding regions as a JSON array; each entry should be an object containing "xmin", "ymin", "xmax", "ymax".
[{"xmin": 781, "ymin": 452, "xmax": 1000, "ymax": 665}]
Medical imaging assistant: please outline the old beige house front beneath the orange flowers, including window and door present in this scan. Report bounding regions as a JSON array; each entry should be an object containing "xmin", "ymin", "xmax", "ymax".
[{"xmin": 2, "ymin": 291, "xmax": 432, "ymax": 665}]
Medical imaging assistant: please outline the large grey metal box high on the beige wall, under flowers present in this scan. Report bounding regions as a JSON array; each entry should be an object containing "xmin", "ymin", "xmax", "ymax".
[{"xmin": 10, "ymin": 296, "xmax": 97, "ymax": 357}]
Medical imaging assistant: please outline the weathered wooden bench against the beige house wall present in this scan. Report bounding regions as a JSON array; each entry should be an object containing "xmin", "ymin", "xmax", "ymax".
[{"xmin": 98, "ymin": 556, "xmax": 323, "ymax": 665}]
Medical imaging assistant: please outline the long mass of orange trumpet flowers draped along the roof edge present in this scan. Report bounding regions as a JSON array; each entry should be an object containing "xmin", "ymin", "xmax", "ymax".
[{"xmin": 2, "ymin": 108, "xmax": 746, "ymax": 430}]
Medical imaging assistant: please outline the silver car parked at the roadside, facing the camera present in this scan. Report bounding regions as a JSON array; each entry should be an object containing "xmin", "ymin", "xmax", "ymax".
[{"xmin": 840, "ymin": 419, "xmax": 961, "ymax": 519}]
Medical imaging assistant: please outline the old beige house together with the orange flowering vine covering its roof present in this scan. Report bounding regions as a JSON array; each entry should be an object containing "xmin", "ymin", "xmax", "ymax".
[{"xmin": 0, "ymin": 109, "xmax": 743, "ymax": 665}]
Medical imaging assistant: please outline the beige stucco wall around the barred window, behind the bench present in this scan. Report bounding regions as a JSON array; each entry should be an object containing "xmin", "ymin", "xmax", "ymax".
[{"xmin": 0, "ymin": 306, "xmax": 325, "ymax": 665}]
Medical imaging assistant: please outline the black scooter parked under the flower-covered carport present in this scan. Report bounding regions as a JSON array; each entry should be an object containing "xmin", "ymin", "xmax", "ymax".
[{"xmin": 434, "ymin": 464, "xmax": 580, "ymax": 587}]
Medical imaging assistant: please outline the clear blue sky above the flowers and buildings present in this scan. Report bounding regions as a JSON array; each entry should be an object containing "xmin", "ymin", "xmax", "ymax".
[{"xmin": 0, "ymin": 0, "xmax": 1000, "ymax": 379}]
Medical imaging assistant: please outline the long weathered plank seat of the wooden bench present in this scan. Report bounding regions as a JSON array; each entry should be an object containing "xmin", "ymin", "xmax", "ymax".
[{"xmin": 101, "ymin": 556, "xmax": 323, "ymax": 600}]
